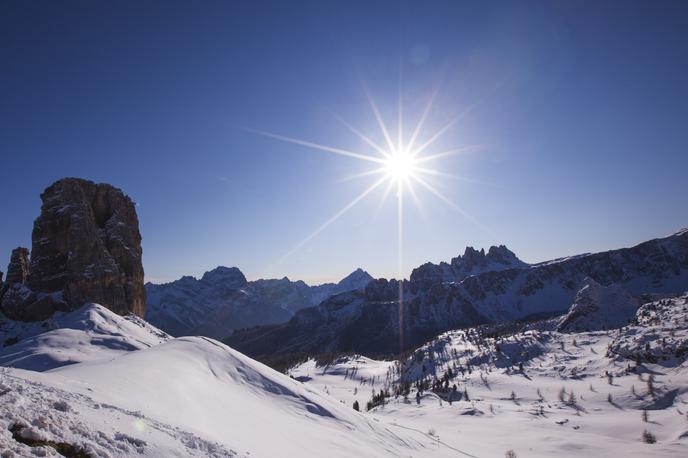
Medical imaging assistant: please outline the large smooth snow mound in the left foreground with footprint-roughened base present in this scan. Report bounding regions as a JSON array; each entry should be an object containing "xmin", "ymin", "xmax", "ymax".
[{"xmin": 0, "ymin": 337, "xmax": 440, "ymax": 457}]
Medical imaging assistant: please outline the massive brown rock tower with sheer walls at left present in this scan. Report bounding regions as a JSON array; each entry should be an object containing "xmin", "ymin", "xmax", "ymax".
[{"xmin": 2, "ymin": 178, "xmax": 146, "ymax": 320}]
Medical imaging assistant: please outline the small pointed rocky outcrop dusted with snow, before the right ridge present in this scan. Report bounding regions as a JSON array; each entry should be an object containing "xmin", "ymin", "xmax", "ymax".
[{"xmin": 557, "ymin": 277, "xmax": 640, "ymax": 332}]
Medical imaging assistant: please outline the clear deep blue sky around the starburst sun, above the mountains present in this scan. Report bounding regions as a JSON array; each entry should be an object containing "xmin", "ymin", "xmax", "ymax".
[{"xmin": 0, "ymin": 1, "xmax": 688, "ymax": 282}]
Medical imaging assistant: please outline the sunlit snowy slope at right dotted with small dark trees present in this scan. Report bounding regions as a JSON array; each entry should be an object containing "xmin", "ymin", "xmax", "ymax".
[{"xmin": 290, "ymin": 297, "xmax": 688, "ymax": 458}]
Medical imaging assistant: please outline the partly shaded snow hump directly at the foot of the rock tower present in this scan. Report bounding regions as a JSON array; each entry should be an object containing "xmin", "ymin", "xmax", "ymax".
[{"xmin": 0, "ymin": 304, "xmax": 169, "ymax": 371}]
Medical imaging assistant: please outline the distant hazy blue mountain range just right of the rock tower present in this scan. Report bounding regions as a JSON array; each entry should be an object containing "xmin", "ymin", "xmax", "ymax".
[{"xmin": 146, "ymin": 266, "xmax": 373, "ymax": 338}]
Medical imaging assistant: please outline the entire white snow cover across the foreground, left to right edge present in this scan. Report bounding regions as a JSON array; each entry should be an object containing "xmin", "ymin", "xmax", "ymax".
[{"xmin": 0, "ymin": 296, "xmax": 688, "ymax": 458}]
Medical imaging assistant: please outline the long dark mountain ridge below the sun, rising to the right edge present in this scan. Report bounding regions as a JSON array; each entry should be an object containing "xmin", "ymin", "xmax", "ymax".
[{"xmin": 227, "ymin": 231, "xmax": 688, "ymax": 362}]
